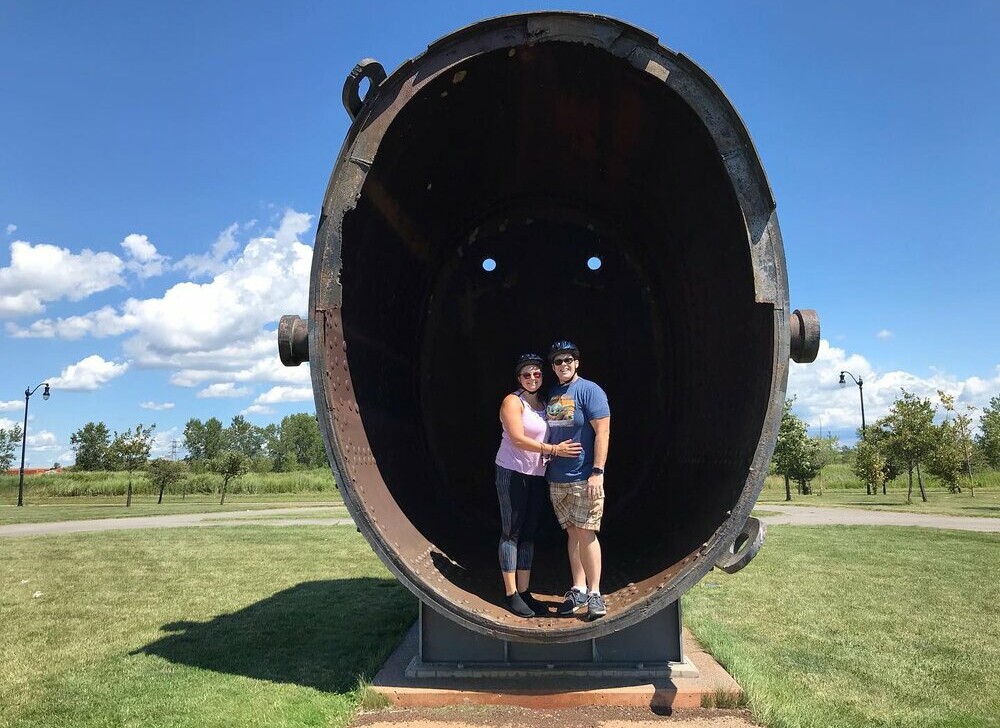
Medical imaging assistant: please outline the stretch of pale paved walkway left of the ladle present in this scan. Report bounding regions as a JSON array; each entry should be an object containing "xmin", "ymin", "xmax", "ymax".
[{"xmin": 0, "ymin": 506, "xmax": 354, "ymax": 537}]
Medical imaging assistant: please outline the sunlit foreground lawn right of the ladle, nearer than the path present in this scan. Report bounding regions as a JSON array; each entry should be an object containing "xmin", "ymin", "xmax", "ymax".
[{"xmin": 683, "ymin": 526, "xmax": 1000, "ymax": 728}]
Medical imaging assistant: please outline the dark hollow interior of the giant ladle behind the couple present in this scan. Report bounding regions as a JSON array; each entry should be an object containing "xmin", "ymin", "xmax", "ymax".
[{"xmin": 341, "ymin": 42, "xmax": 774, "ymax": 616}]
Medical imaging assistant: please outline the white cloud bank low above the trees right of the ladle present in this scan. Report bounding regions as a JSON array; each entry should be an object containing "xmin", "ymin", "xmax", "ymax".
[{"xmin": 788, "ymin": 339, "xmax": 1000, "ymax": 439}]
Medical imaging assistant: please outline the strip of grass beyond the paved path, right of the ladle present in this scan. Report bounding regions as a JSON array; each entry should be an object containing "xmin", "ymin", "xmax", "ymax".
[{"xmin": 757, "ymin": 485, "xmax": 1000, "ymax": 518}]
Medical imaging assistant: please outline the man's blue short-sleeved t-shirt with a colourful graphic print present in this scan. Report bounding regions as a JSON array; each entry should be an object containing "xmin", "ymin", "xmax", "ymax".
[{"xmin": 545, "ymin": 377, "xmax": 611, "ymax": 483}]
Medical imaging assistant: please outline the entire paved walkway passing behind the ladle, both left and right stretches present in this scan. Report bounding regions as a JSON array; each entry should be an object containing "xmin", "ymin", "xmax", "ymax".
[{"xmin": 0, "ymin": 503, "xmax": 1000, "ymax": 537}]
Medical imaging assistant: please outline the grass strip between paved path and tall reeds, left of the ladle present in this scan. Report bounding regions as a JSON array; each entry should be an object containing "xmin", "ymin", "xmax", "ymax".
[{"xmin": 0, "ymin": 491, "xmax": 346, "ymax": 525}]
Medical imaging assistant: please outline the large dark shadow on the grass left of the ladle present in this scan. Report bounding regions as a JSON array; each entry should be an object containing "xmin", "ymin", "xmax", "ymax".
[{"xmin": 133, "ymin": 577, "xmax": 417, "ymax": 693}]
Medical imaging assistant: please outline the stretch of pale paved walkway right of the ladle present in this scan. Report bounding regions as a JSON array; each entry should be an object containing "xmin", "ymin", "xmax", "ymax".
[{"xmin": 757, "ymin": 503, "xmax": 1000, "ymax": 533}]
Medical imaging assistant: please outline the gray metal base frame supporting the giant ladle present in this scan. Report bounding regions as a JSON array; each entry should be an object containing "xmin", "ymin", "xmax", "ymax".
[{"xmin": 406, "ymin": 602, "xmax": 698, "ymax": 678}]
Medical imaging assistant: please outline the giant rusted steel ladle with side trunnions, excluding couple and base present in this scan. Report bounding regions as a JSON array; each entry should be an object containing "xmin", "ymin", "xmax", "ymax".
[{"xmin": 279, "ymin": 13, "xmax": 818, "ymax": 642}]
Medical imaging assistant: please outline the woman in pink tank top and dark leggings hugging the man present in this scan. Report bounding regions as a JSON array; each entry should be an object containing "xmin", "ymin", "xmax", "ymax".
[{"xmin": 496, "ymin": 354, "xmax": 581, "ymax": 617}]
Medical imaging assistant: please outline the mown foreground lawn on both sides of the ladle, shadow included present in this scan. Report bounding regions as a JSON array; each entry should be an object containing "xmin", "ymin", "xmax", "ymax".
[{"xmin": 0, "ymin": 524, "xmax": 1000, "ymax": 728}]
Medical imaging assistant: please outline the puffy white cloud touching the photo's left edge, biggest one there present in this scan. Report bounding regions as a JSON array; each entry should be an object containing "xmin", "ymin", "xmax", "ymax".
[{"xmin": 0, "ymin": 240, "xmax": 124, "ymax": 316}]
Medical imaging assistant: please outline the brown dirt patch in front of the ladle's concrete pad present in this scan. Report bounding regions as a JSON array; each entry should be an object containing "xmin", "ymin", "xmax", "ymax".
[{"xmin": 351, "ymin": 705, "xmax": 760, "ymax": 728}]
